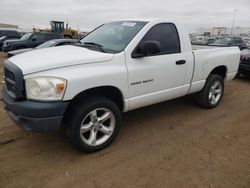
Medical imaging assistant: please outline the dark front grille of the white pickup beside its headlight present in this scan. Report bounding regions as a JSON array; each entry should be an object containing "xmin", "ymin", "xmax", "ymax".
[{"xmin": 4, "ymin": 60, "xmax": 25, "ymax": 100}]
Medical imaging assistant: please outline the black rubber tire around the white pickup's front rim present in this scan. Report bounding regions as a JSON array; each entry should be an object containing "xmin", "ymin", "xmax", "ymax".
[{"xmin": 66, "ymin": 97, "xmax": 121, "ymax": 153}]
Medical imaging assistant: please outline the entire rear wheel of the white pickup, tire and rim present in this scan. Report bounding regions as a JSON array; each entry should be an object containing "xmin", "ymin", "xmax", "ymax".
[{"xmin": 197, "ymin": 74, "xmax": 224, "ymax": 109}]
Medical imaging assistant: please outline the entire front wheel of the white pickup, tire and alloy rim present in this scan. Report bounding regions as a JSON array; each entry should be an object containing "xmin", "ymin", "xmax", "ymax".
[{"xmin": 66, "ymin": 97, "xmax": 121, "ymax": 152}]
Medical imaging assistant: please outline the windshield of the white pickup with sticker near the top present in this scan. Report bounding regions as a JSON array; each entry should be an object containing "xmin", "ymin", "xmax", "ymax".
[{"xmin": 80, "ymin": 21, "xmax": 147, "ymax": 53}]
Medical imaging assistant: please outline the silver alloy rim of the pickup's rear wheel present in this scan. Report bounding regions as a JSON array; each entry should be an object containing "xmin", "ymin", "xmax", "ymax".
[{"xmin": 208, "ymin": 81, "xmax": 223, "ymax": 105}]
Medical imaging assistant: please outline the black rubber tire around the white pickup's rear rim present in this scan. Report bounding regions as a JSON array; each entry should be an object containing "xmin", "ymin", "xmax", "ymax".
[{"xmin": 196, "ymin": 74, "xmax": 224, "ymax": 109}]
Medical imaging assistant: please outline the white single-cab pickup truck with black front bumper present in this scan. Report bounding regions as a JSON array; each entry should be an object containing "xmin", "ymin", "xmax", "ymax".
[{"xmin": 3, "ymin": 19, "xmax": 240, "ymax": 152}]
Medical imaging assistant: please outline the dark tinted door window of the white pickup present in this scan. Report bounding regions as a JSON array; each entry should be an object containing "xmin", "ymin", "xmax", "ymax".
[{"xmin": 142, "ymin": 23, "xmax": 181, "ymax": 55}]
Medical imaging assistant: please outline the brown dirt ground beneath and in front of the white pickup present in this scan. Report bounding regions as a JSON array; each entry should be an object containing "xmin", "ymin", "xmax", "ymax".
[{"xmin": 0, "ymin": 51, "xmax": 250, "ymax": 188}]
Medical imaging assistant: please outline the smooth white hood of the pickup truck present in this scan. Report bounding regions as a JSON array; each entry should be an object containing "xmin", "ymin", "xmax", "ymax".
[{"xmin": 9, "ymin": 46, "xmax": 114, "ymax": 75}]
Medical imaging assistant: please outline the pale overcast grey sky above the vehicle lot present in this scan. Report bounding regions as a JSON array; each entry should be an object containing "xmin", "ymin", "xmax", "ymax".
[{"xmin": 0, "ymin": 0, "xmax": 250, "ymax": 32}]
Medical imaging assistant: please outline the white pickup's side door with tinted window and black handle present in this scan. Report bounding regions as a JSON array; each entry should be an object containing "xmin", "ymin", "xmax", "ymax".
[{"xmin": 126, "ymin": 23, "xmax": 189, "ymax": 109}]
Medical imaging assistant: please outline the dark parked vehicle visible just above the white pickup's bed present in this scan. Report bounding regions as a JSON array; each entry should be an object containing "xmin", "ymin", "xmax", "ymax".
[{"xmin": 210, "ymin": 37, "xmax": 246, "ymax": 50}]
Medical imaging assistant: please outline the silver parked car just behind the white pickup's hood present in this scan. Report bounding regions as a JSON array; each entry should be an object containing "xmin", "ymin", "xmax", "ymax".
[{"xmin": 8, "ymin": 39, "xmax": 78, "ymax": 57}]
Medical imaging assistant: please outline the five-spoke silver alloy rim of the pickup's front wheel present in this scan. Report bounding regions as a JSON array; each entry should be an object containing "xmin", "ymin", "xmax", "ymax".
[{"xmin": 80, "ymin": 108, "xmax": 115, "ymax": 146}]
